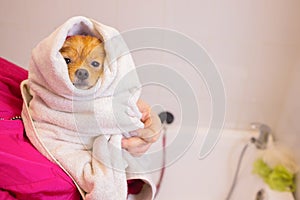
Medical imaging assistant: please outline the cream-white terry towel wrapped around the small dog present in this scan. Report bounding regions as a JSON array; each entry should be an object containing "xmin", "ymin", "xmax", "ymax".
[{"xmin": 21, "ymin": 16, "xmax": 155, "ymax": 200}]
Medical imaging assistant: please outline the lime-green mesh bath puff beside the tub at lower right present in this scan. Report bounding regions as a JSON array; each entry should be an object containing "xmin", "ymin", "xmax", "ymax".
[{"xmin": 253, "ymin": 159, "xmax": 296, "ymax": 192}]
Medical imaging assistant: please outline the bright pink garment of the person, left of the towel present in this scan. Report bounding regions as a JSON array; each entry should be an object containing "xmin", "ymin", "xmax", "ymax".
[{"xmin": 0, "ymin": 58, "xmax": 80, "ymax": 200}]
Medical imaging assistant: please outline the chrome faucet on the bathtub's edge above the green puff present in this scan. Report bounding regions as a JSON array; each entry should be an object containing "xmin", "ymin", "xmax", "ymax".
[{"xmin": 251, "ymin": 122, "xmax": 271, "ymax": 149}]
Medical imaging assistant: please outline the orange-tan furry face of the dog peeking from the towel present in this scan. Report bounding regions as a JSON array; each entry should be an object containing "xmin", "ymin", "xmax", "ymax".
[{"xmin": 60, "ymin": 35, "xmax": 105, "ymax": 89}]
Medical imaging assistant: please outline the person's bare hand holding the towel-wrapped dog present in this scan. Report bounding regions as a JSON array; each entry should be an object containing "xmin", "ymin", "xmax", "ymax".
[{"xmin": 122, "ymin": 100, "xmax": 161, "ymax": 156}]
